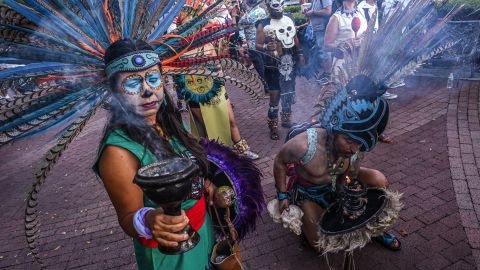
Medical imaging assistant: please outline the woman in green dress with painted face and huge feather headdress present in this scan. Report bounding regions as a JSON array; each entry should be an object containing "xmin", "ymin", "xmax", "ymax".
[{"xmin": 0, "ymin": 0, "xmax": 263, "ymax": 269}]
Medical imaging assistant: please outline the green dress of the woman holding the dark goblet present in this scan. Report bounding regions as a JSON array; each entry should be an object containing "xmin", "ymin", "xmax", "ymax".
[{"xmin": 93, "ymin": 129, "xmax": 215, "ymax": 270}]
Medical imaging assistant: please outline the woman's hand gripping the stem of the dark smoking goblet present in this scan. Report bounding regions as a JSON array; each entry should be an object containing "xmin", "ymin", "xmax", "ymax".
[{"xmin": 145, "ymin": 208, "xmax": 189, "ymax": 247}]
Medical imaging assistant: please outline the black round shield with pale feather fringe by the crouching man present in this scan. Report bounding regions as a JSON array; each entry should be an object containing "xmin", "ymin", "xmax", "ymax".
[{"xmin": 316, "ymin": 188, "xmax": 402, "ymax": 254}]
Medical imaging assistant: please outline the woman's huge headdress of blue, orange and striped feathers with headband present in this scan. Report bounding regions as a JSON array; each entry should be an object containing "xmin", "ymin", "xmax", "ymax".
[{"xmin": 0, "ymin": 0, "xmax": 263, "ymax": 266}]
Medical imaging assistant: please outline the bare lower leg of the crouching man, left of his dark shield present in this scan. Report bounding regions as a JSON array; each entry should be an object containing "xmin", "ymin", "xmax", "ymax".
[{"xmin": 300, "ymin": 200, "xmax": 325, "ymax": 250}]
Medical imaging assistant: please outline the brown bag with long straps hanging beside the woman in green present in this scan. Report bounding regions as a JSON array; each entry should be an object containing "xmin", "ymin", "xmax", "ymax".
[{"xmin": 210, "ymin": 206, "xmax": 243, "ymax": 270}]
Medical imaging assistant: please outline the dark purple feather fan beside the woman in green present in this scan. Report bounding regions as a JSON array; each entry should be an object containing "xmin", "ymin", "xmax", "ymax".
[{"xmin": 200, "ymin": 139, "xmax": 266, "ymax": 240}]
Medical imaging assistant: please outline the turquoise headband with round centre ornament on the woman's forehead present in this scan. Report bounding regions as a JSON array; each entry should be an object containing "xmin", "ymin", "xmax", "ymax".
[{"xmin": 105, "ymin": 51, "xmax": 160, "ymax": 78}]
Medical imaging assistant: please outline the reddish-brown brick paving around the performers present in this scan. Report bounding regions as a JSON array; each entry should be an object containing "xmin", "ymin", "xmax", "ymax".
[{"xmin": 0, "ymin": 75, "xmax": 480, "ymax": 270}]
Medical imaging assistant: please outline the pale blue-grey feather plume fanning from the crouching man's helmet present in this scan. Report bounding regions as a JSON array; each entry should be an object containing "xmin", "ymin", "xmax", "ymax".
[{"xmin": 337, "ymin": 0, "xmax": 458, "ymax": 85}]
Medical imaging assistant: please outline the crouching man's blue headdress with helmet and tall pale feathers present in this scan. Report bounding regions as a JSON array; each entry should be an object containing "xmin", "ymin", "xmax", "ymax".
[{"xmin": 316, "ymin": 0, "xmax": 455, "ymax": 151}]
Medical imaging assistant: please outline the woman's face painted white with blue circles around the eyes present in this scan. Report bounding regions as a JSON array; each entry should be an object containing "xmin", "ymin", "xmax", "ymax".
[{"xmin": 115, "ymin": 66, "xmax": 164, "ymax": 118}]
